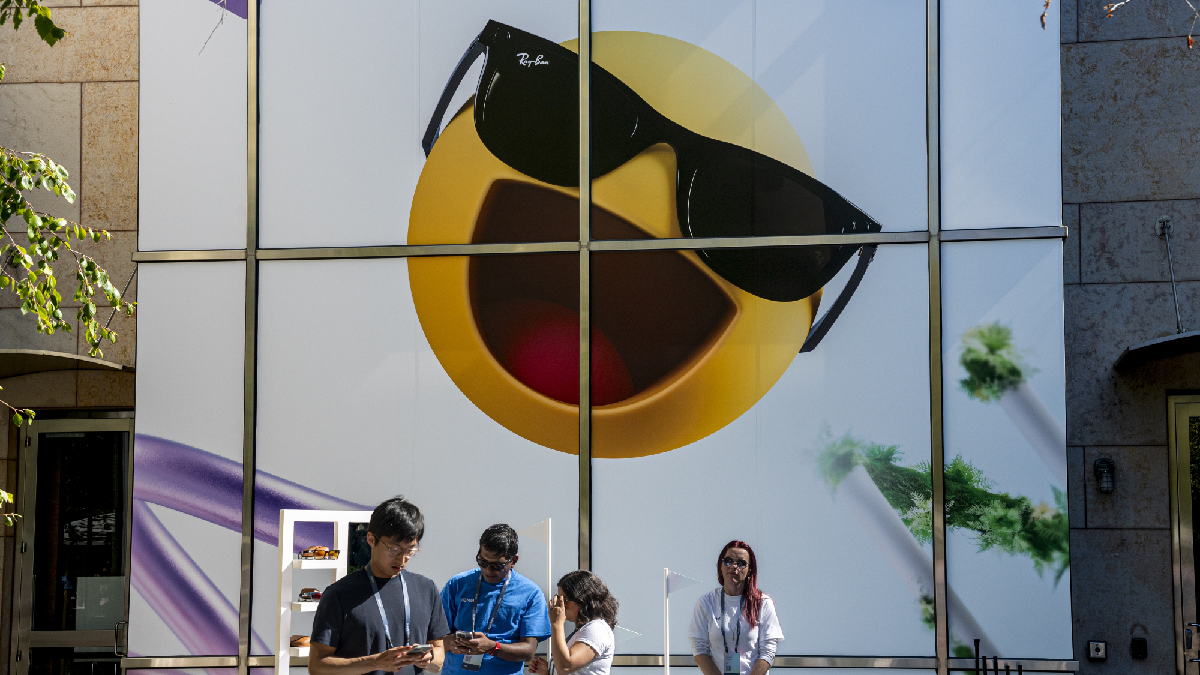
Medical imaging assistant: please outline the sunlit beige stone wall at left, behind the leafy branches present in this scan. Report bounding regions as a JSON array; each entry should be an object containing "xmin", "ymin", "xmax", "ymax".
[{"xmin": 0, "ymin": 0, "xmax": 138, "ymax": 674}]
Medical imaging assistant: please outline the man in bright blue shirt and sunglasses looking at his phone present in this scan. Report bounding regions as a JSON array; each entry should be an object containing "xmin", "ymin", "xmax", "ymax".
[{"xmin": 442, "ymin": 524, "xmax": 550, "ymax": 675}]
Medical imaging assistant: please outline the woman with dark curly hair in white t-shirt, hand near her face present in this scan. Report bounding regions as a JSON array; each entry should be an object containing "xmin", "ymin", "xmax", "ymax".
[{"xmin": 529, "ymin": 569, "xmax": 618, "ymax": 675}]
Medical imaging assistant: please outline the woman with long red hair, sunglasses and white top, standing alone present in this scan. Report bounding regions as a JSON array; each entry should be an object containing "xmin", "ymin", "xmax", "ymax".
[{"xmin": 688, "ymin": 539, "xmax": 784, "ymax": 675}]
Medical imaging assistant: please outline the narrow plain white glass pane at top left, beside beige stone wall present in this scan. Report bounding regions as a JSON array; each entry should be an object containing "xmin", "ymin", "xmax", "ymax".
[{"xmin": 138, "ymin": 0, "xmax": 247, "ymax": 251}]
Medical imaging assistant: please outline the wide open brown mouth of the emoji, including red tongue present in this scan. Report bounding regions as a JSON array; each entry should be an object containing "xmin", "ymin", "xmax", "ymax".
[{"xmin": 469, "ymin": 180, "xmax": 737, "ymax": 406}]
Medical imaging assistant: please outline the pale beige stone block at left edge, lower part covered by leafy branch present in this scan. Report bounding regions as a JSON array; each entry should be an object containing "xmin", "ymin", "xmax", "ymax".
[{"xmin": 0, "ymin": 83, "xmax": 80, "ymax": 223}]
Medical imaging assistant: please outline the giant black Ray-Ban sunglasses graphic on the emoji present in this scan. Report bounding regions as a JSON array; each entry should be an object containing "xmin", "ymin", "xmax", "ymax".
[{"xmin": 421, "ymin": 20, "xmax": 882, "ymax": 352}]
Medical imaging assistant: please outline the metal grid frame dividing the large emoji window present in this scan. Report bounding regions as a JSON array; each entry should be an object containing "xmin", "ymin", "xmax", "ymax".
[{"xmin": 121, "ymin": 0, "xmax": 1079, "ymax": 675}]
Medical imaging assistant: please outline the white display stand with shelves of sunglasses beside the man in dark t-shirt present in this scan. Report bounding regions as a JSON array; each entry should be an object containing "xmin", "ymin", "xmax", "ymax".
[{"xmin": 275, "ymin": 508, "xmax": 371, "ymax": 675}]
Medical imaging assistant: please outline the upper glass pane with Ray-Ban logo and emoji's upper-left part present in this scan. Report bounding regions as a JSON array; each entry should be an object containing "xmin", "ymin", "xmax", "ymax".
[{"xmin": 259, "ymin": 0, "xmax": 578, "ymax": 247}]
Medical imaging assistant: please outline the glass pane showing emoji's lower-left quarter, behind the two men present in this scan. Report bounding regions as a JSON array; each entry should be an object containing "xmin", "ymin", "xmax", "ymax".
[{"xmin": 253, "ymin": 255, "xmax": 580, "ymax": 653}]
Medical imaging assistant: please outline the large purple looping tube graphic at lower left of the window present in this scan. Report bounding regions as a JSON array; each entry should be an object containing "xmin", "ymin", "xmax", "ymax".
[{"xmin": 132, "ymin": 434, "xmax": 371, "ymax": 655}]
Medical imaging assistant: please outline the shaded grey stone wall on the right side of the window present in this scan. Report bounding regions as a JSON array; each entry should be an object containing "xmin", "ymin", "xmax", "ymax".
[{"xmin": 1060, "ymin": 0, "xmax": 1200, "ymax": 674}]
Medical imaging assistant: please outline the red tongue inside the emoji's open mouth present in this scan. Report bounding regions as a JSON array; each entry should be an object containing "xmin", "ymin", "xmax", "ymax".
[{"xmin": 502, "ymin": 300, "xmax": 634, "ymax": 406}]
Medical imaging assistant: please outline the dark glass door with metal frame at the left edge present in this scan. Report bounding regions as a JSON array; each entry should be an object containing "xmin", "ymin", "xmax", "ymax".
[{"xmin": 10, "ymin": 419, "xmax": 133, "ymax": 675}]
